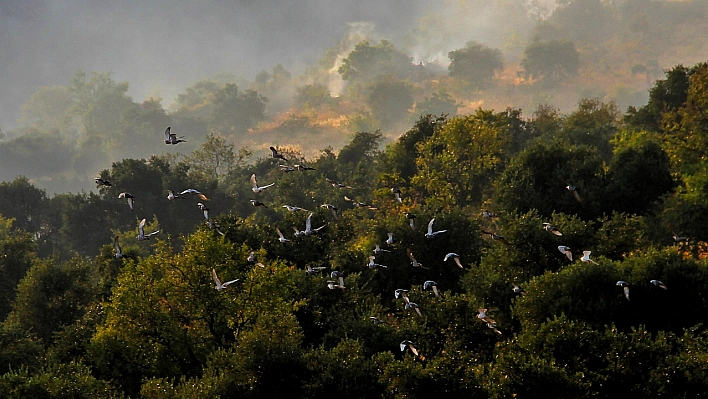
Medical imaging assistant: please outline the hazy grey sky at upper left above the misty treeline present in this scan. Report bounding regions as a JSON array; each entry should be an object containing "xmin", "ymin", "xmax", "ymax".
[{"xmin": 0, "ymin": 0, "xmax": 445, "ymax": 131}]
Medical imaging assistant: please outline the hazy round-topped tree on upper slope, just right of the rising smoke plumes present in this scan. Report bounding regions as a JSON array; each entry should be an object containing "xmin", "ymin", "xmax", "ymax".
[{"xmin": 447, "ymin": 42, "xmax": 504, "ymax": 88}]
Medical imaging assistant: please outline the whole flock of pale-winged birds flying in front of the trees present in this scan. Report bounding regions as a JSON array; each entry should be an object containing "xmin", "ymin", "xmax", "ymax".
[{"xmin": 95, "ymin": 127, "xmax": 672, "ymax": 356}]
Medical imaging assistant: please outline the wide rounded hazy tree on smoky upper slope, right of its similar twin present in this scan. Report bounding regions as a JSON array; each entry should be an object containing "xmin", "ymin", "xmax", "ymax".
[{"xmin": 521, "ymin": 40, "xmax": 580, "ymax": 83}]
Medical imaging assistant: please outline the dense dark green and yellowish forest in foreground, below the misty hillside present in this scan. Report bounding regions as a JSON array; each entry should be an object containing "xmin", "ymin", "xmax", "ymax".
[{"xmin": 0, "ymin": 57, "xmax": 708, "ymax": 398}]
